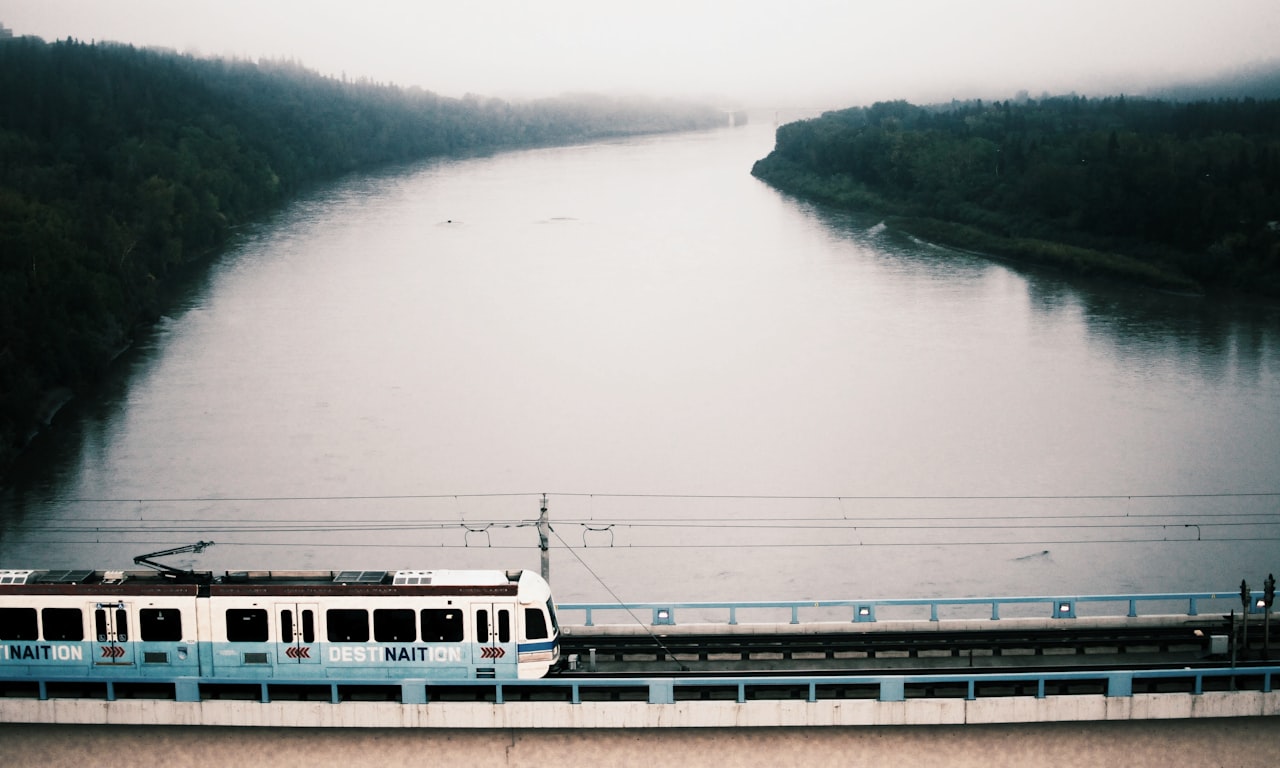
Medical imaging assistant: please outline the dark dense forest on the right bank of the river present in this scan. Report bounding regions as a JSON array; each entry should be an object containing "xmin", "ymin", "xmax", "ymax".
[{"xmin": 753, "ymin": 96, "xmax": 1280, "ymax": 297}]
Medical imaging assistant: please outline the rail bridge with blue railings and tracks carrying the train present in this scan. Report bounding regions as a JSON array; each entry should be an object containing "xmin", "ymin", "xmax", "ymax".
[{"xmin": 0, "ymin": 593, "xmax": 1280, "ymax": 730}]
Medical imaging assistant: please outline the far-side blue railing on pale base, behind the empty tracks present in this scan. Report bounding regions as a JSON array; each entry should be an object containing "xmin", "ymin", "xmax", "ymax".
[{"xmin": 557, "ymin": 590, "xmax": 1262, "ymax": 627}]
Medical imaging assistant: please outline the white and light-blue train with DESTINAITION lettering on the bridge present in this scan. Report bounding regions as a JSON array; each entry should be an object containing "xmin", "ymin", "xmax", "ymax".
[{"xmin": 0, "ymin": 570, "xmax": 559, "ymax": 682}]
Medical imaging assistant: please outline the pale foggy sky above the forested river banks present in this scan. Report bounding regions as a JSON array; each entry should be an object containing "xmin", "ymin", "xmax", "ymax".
[{"xmin": 0, "ymin": 0, "xmax": 1280, "ymax": 109}]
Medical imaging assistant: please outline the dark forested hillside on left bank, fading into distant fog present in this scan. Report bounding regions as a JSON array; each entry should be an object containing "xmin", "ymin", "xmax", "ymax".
[{"xmin": 0, "ymin": 38, "xmax": 724, "ymax": 466}]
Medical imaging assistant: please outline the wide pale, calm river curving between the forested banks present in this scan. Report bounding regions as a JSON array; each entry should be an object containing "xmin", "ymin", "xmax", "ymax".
[{"xmin": 0, "ymin": 123, "xmax": 1280, "ymax": 602}]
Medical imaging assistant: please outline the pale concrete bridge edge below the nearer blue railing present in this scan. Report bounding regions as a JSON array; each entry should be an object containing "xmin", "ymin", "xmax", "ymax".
[{"xmin": 0, "ymin": 691, "xmax": 1280, "ymax": 730}]
